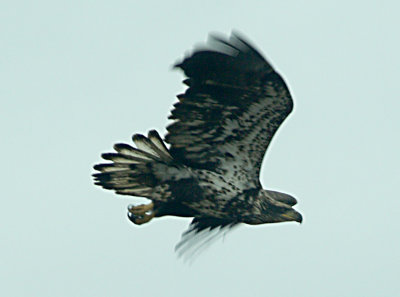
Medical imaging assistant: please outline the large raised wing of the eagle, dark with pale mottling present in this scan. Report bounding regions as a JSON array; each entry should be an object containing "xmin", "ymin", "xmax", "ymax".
[{"xmin": 165, "ymin": 33, "xmax": 293, "ymax": 188}]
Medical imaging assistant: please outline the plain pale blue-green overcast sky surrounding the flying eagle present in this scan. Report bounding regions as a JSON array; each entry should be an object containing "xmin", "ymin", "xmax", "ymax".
[{"xmin": 0, "ymin": 0, "xmax": 400, "ymax": 297}]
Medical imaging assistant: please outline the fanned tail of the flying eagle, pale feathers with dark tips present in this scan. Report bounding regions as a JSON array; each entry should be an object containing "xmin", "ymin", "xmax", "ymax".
[{"xmin": 93, "ymin": 130, "xmax": 173, "ymax": 198}]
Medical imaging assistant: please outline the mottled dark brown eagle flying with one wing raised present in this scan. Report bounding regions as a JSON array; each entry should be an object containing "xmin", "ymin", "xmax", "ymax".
[{"xmin": 93, "ymin": 32, "xmax": 302, "ymax": 254}]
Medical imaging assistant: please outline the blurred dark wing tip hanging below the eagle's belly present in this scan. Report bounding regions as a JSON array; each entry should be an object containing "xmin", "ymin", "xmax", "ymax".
[{"xmin": 175, "ymin": 217, "xmax": 238, "ymax": 261}]
